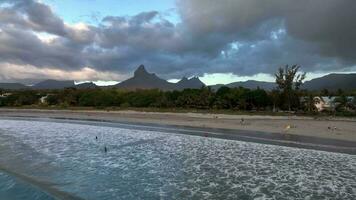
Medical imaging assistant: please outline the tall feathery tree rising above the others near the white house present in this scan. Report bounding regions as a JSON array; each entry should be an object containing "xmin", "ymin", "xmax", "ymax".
[{"xmin": 275, "ymin": 65, "xmax": 306, "ymax": 111}]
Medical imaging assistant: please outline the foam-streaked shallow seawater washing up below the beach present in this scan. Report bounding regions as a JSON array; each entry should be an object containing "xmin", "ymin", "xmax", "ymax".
[{"xmin": 0, "ymin": 120, "xmax": 356, "ymax": 199}]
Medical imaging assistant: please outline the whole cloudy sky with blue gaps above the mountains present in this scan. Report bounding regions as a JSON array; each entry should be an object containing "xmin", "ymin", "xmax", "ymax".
[{"xmin": 0, "ymin": 0, "xmax": 356, "ymax": 84}]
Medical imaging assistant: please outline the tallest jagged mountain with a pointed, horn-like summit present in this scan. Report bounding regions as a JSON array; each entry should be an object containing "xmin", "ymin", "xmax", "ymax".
[{"xmin": 115, "ymin": 65, "xmax": 174, "ymax": 90}]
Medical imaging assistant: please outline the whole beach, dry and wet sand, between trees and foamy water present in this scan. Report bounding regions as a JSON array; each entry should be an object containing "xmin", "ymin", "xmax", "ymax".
[{"xmin": 0, "ymin": 109, "xmax": 356, "ymax": 154}]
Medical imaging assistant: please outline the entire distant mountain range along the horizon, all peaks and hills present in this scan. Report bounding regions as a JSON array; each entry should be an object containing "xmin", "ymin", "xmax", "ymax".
[{"xmin": 0, "ymin": 65, "xmax": 356, "ymax": 91}]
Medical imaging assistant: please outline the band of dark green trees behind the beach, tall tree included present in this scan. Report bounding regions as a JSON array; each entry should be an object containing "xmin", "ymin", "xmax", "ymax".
[{"xmin": 0, "ymin": 65, "xmax": 356, "ymax": 113}]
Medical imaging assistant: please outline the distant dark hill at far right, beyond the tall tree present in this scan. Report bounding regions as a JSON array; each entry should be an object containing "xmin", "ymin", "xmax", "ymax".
[{"xmin": 302, "ymin": 74, "xmax": 356, "ymax": 91}]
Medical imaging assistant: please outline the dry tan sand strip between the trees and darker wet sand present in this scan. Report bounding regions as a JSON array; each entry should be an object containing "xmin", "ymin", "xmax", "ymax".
[{"xmin": 0, "ymin": 109, "xmax": 356, "ymax": 142}]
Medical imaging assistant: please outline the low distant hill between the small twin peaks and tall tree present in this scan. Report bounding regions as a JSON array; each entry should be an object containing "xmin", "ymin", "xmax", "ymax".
[{"xmin": 211, "ymin": 80, "xmax": 277, "ymax": 90}]
